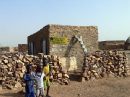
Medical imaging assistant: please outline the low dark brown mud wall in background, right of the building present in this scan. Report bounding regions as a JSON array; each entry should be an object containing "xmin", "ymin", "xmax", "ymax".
[{"xmin": 99, "ymin": 40, "xmax": 125, "ymax": 50}]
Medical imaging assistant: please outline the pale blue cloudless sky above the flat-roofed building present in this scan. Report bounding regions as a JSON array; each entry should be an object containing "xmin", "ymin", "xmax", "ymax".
[{"xmin": 0, "ymin": 0, "xmax": 130, "ymax": 46}]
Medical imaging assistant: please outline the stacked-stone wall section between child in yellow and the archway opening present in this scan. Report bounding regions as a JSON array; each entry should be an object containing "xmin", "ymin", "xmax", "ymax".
[{"xmin": 48, "ymin": 55, "xmax": 69, "ymax": 85}]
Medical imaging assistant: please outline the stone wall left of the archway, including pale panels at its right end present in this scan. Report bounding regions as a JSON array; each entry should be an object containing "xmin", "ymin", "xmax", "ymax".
[{"xmin": 0, "ymin": 52, "xmax": 71, "ymax": 89}]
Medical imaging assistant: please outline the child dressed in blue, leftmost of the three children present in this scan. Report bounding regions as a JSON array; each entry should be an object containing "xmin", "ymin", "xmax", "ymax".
[{"xmin": 23, "ymin": 64, "xmax": 35, "ymax": 97}]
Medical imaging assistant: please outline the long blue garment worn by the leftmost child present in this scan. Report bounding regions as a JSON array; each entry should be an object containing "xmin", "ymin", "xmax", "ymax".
[{"xmin": 24, "ymin": 73, "xmax": 35, "ymax": 97}]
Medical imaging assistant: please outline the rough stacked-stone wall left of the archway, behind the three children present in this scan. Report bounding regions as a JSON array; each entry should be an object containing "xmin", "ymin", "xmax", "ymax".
[{"xmin": 0, "ymin": 53, "xmax": 69, "ymax": 89}]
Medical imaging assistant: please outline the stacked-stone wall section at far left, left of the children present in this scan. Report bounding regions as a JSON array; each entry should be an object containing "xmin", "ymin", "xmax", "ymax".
[{"xmin": 0, "ymin": 53, "xmax": 36, "ymax": 89}]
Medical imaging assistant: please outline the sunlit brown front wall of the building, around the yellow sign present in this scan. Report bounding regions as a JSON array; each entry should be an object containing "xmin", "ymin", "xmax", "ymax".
[{"xmin": 49, "ymin": 25, "xmax": 98, "ymax": 66}]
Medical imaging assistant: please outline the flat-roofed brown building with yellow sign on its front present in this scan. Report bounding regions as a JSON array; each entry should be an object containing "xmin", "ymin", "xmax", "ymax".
[{"xmin": 28, "ymin": 25, "xmax": 98, "ymax": 67}]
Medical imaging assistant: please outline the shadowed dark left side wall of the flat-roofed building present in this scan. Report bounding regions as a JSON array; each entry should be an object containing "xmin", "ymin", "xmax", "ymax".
[{"xmin": 28, "ymin": 25, "xmax": 49, "ymax": 55}]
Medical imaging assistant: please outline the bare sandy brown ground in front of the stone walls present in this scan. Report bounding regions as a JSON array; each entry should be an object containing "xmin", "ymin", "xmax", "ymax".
[{"xmin": 0, "ymin": 52, "xmax": 130, "ymax": 97}]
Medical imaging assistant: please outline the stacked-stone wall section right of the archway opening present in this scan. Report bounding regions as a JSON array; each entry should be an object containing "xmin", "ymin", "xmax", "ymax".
[{"xmin": 82, "ymin": 50, "xmax": 129, "ymax": 81}]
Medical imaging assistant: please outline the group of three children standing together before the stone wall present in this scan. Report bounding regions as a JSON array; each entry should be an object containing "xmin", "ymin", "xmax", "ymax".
[{"xmin": 23, "ymin": 58, "xmax": 50, "ymax": 97}]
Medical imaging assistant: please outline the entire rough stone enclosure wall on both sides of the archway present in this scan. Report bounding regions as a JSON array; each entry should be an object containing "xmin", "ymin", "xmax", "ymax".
[{"xmin": 0, "ymin": 50, "xmax": 130, "ymax": 89}]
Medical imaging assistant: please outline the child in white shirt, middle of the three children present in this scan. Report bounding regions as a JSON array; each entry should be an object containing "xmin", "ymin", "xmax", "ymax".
[{"xmin": 35, "ymin": 66, "xmax": 45, "ymax": 97}]
